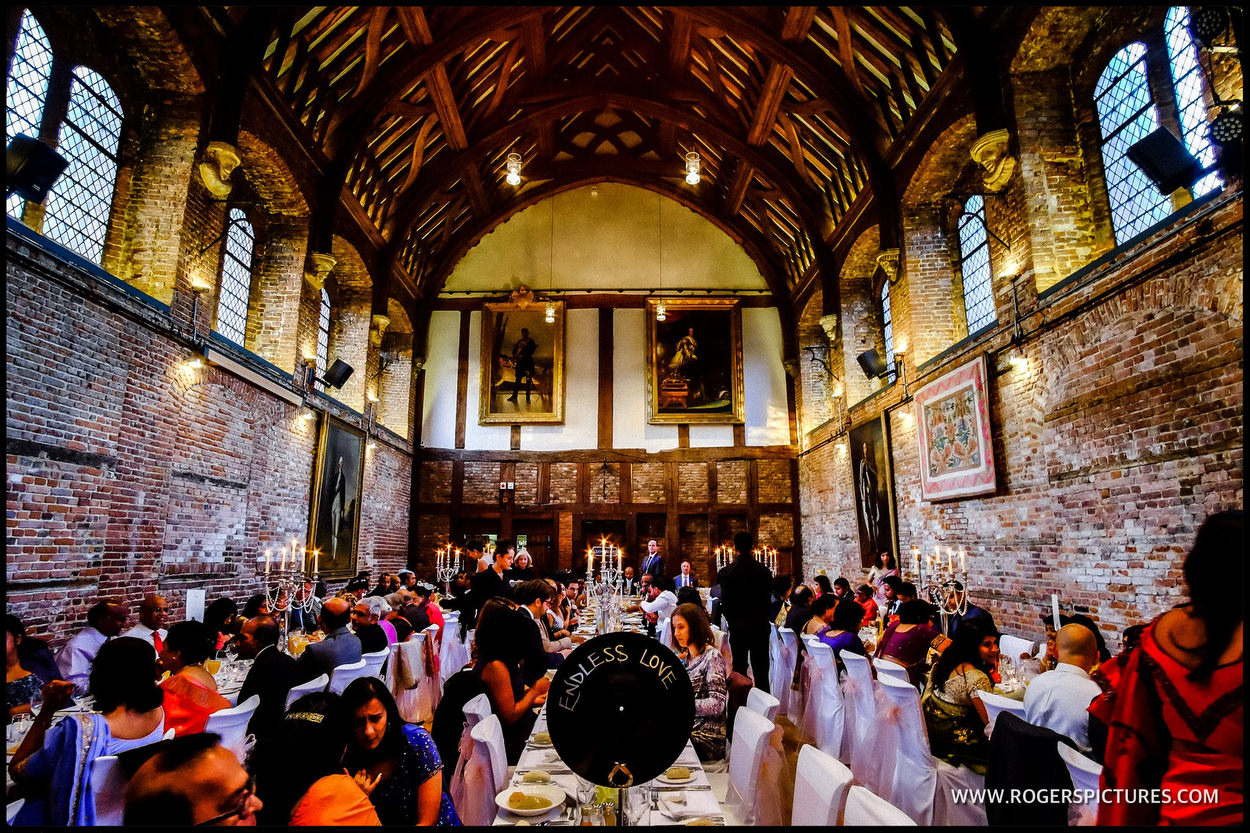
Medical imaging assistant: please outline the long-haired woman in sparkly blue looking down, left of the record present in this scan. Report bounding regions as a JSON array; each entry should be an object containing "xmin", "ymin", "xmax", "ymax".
[{"xmin": 343, "ymin": 677, "xmax": 460, "ymax": 827}]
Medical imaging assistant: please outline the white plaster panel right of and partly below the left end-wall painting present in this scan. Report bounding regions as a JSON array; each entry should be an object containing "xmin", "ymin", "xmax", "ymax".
[{"xmin": 522, "ymin": 309, "xmax": 599, "ymax": 452}]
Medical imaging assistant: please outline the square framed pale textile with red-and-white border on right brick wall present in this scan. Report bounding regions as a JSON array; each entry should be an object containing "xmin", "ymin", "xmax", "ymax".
[{"xmin": 915, "ymin": 355, "xmax": 998, "ymax": 500}]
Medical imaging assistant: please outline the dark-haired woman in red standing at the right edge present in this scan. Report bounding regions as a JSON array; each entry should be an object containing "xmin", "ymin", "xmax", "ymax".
[{"xmin": 1098, "ymin": 510, "xmax": 1245, "ymax": 825}]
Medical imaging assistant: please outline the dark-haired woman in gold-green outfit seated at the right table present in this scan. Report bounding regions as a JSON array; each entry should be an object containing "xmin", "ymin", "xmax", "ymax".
[{"xmin": 921, "ymin": 622, "xmax": 999, "ymax": 775}]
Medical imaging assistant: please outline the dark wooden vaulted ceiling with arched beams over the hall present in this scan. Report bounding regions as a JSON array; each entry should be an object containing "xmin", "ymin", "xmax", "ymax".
[{"xmin": 238, "ymin": 6, "xmax": 955, "ymax": 298}]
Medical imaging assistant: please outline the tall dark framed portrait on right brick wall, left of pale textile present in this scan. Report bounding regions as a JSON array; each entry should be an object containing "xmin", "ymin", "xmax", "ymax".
[{"xmin": 850, "ymin": 415, "xmax": 899, "ymax": 567}]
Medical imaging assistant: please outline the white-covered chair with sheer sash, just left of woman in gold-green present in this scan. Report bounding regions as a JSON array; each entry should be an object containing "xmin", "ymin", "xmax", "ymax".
[{"xmin": 878, "ymin": 677, "xmax": 986, "ymax": 827}]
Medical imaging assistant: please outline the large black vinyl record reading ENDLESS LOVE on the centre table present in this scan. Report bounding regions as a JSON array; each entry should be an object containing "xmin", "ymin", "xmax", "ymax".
[{"xmin": 546, "ymin": 633, "xmax": 695, "ymax": 787}]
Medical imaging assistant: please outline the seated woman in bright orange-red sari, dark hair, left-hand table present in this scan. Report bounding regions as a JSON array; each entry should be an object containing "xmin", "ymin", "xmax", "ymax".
[{"xmin": 160, "ymin": 619, "xmax": 230, "ymax": 735}]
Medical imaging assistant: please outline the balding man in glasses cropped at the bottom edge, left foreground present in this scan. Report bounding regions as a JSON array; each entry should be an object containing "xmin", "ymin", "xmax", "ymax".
[{"xmin": 123, "ymin": 732, "xmax": 263, "ymax": 828}]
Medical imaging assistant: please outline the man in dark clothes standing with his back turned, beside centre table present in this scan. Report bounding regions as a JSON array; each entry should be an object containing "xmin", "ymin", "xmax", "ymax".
[{"xmin": 716, "ymin": 532, "xmax": 773, "ymax": 692}]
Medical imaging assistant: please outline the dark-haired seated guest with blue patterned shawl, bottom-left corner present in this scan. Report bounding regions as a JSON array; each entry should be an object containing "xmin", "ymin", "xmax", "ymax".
[{"xmin": 9, "ymin": 637, "xmax": 165, "ymax": 827}]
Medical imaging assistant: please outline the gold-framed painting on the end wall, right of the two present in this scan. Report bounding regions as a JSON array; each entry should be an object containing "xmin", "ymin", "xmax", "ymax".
[{"xmin": 646, "ymin": 298, "xmax": 745, "ymax": 424}]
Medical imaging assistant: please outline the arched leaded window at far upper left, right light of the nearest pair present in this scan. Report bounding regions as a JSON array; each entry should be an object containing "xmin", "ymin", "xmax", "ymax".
[{"xmin": 44, "ymin": 66, "xmax": 121, "ymax": 263}]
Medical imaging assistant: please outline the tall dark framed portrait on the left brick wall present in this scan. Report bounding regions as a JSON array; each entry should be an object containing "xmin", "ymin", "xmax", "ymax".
[{"xmin": 309, "ymin": 414, "xmax": 365, "ymax": 577}]
